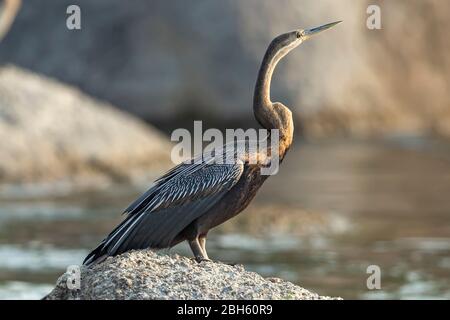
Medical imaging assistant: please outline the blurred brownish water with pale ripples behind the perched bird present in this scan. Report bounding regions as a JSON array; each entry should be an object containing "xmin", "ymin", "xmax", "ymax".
[{"xmin": 0, "ymin": 138, "xmax": 450, "ymax": 299}]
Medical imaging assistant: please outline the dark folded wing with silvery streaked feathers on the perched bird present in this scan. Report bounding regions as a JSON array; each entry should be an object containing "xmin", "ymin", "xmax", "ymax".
[{"xmin": 83, "ymin": 163, "xmax": 244, "ymax": 264}]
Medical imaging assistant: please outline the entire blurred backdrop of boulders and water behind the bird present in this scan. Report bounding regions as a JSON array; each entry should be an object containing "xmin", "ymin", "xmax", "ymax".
[{"xmin": 0, "ymin": 0, "xmax": 450, "ymax": 299}]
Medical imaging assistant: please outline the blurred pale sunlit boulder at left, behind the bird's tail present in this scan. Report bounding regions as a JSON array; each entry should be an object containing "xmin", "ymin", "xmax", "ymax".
[{"xmin": 0, "ymin": 66, "xmax": 170, "ymax": 183}]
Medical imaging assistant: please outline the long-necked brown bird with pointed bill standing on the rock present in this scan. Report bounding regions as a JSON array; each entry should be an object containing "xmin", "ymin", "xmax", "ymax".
[{"xmin": 83, "ymin": 22, "xmax": 338, "ymax": 265}]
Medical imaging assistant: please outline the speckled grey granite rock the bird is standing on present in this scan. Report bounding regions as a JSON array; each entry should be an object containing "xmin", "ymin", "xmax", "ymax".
[{"xmin": 45, "ymin": 250, "xmax": 342, "ymax": 300}]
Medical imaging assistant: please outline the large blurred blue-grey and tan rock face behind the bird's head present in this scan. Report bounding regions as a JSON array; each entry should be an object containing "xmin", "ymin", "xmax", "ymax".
[{"xmin": 0, "ymin": 0, "xmax": 450, "ymax": 136}]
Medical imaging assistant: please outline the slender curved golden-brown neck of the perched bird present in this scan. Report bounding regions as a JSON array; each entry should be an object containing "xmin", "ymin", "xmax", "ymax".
[{"xmin": 253, "ymin": 44, "xmax": 294, "ymax": 159}]
